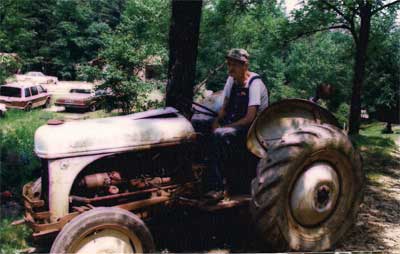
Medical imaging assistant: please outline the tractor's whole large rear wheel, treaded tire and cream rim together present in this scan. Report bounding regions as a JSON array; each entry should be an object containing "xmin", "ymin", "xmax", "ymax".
[{"xmin": 250, "ymin": 124, "xmax": 363, "ymax": 251}]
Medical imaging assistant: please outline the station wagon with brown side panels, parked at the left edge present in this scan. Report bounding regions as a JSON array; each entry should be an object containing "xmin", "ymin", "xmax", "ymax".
[{"xmin": 0, "ymin": 83, "xmax": 51, "ymax": 111}]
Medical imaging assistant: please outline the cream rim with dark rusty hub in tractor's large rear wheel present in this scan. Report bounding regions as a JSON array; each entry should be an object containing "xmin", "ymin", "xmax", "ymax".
[{"xmin": 290, "ymin": 162, "xmax": 340, "ymax": 227}]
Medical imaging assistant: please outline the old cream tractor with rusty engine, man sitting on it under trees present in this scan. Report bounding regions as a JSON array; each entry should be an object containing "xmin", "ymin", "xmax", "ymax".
[{"xmin": 18, "ymin": 93, "xmax": 363, "ymax": 253}]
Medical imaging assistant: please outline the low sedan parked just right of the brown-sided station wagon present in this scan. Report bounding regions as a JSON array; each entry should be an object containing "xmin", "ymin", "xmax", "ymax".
[{"xmin": 55, "ymin": 87, "xmax": 108, "ymax": 112}]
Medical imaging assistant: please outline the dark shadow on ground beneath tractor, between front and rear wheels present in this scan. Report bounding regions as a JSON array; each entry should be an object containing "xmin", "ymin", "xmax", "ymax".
[{"xmin": 149, "ymin": 208, "xmax": 259, "ymax": 252}]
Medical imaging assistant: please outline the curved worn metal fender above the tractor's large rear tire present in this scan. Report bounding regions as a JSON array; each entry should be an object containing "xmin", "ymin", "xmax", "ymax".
[{"xmin": 247, "ymin": 99, "xmax": 340, "ymax": 158}]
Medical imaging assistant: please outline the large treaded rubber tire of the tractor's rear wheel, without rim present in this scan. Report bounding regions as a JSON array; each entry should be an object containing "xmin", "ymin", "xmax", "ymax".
[{"xmin": 250, "ymin": 124, "xmax": 364, "ymax": 251}]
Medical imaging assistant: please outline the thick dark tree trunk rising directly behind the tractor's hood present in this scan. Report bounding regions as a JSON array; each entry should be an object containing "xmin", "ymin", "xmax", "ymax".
[{"xmin": 166, "ymin": 0, "xmax": 202, "ymax": 115}]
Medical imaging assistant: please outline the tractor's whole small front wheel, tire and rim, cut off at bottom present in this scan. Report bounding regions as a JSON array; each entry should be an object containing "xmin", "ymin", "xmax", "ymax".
[{"xmin": 50, "ymin": 207, "xmax": 155, "ymax": 253}]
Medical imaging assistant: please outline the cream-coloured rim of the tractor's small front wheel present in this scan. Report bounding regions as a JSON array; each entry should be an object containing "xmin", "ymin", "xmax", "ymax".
[{"xmin": 68, "ymin": 225, "xmax": 143, "ymax": 254}]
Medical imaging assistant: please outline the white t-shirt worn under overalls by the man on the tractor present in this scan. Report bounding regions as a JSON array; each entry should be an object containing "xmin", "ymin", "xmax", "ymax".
[{"xmin": 223, "ymin": 72, "xmax": 268, "ymax": 113}]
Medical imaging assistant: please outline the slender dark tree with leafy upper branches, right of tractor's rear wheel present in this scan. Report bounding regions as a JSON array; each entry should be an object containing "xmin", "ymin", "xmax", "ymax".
[{"xmin": 294, "ymin": 0, "xmax": 400, "ymax": 134}]
